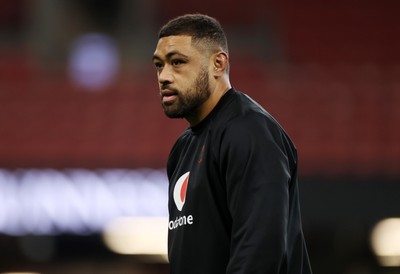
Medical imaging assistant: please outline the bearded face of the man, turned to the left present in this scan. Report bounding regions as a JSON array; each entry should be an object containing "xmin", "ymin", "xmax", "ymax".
[{"xmin": 153, "ymin": 35, "xmax": 211, "ymax": 118}]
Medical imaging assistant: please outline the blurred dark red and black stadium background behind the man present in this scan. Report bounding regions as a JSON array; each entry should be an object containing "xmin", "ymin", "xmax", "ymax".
[{"xmin": 0, "ymin": 0, "xmax": 400, "ymax": 274}]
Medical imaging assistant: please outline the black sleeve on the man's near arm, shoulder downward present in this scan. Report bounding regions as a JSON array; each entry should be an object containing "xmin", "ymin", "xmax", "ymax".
[{"xmin": 220, "ymin": 114, "xmax": 291, "ymax": 274}]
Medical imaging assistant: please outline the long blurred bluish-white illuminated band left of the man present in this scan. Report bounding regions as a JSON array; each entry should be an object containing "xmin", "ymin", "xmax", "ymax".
[{"xmin": 0, "ymin": 169, "xmax": 168, "ymax": 236}]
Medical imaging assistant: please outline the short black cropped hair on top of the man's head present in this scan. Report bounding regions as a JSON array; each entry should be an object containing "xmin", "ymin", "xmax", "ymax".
[{"xmin": 158, "ymin": 13, "xmax": 228, "ymax": 53}]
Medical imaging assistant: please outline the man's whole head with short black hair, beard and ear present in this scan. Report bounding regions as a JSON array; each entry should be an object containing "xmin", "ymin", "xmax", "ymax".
[{"xmin": 153, "ymin": 14, "xmax": 230, "ymax": 125}]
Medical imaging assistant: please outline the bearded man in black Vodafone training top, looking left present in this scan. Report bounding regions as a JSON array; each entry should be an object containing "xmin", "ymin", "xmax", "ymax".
[{"xmin": 153, "ymin": 14, "xmax": 311, "ymax": 274}]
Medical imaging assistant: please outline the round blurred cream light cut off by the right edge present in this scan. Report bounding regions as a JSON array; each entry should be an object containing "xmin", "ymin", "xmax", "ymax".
[{"xmin": 371, "ymin": 218, "xmax": 400, "ymax": 267}]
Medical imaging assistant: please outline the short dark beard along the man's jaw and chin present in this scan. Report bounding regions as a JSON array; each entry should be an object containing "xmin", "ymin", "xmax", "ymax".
[{"xmin": 162, "ymin": 68, "xmax": 211, "ymax": 118}]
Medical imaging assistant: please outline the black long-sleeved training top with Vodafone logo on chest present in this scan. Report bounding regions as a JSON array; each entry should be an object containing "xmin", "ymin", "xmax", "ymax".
[{"xmin": 167, "ymin": 89, "xmax": 311, "ymax": 274}]
